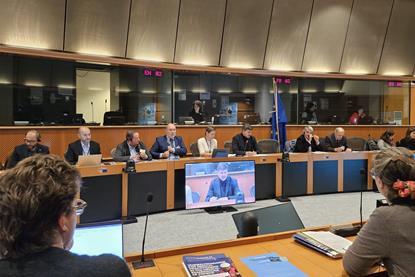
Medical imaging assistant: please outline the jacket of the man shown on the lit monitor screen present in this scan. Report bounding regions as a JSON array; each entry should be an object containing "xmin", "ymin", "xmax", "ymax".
[{"xmin": 205, "ymin": 176, "xmax": 243, "ymax": 202}]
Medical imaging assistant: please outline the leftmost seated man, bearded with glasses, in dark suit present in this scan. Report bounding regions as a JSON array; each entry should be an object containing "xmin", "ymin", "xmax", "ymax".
[{"xmin": 6, "ymin": 130, "xmax": 49, "ymax": 168}]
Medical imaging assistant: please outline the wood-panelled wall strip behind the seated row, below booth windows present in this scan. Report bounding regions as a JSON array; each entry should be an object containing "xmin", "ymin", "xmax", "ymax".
[{"xmin": 0, "ymin": 125, "xmax": 408, "ymax": 162}]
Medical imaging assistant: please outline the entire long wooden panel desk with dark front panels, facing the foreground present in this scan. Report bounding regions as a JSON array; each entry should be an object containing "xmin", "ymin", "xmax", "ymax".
[{"xmin": 75, "ymin": 152, "xmax": 374, "ymax": 223}]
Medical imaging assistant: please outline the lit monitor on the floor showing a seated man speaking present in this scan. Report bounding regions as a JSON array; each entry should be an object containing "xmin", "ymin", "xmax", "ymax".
[{"xmin": 185, "ymin": 158, "xmax": 255, "ymax": 209}]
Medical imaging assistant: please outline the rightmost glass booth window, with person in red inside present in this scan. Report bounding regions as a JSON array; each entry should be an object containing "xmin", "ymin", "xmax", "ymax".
[{"xmin": 298, "ymin": 78, "xmax": 409, "ymax": 125}]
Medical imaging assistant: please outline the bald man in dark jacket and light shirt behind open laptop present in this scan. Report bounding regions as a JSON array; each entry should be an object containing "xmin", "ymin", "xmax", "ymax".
[{"xmin": 65, "ymin": 126, "xmax": 101, "ymax": 164}]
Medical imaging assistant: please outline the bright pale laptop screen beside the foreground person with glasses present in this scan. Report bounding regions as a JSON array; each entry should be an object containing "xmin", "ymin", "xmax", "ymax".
[{"xmin": 71, "ymin": 224, "xmax": 123, "ymax": 258}]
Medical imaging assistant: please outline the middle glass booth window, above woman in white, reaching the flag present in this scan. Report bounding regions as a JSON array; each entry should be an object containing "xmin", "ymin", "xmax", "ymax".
[{"xmin": 173, "ymin": 72, "xmax": 296, "ymax": 125}]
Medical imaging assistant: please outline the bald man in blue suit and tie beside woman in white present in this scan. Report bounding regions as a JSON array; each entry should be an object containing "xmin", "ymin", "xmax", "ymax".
[{"xmin": 151, "ymin": 123, "xmax": 187, "ymax": 159}]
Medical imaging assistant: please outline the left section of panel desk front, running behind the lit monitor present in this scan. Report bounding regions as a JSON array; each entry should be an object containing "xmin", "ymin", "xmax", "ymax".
[{"xmin": 78, "ymin": 154, "xmax": 281, "ymax": 224}]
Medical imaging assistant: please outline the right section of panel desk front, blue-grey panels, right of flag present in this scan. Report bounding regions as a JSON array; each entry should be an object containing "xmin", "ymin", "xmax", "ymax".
[{"xmin": 277, "ymin": 151, "xmax": 374, "ymax": 196}]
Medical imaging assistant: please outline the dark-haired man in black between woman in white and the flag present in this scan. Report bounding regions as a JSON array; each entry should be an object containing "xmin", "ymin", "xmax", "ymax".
[{"xmin": 232, "ymin": 123, "xmax": 258, "ymax": 156}]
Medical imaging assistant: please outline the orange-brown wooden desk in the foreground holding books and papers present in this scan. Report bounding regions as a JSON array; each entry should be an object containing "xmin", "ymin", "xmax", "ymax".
[{"xmin": 125, "ymin": 223, "xmax": 384, "ymax": 277}]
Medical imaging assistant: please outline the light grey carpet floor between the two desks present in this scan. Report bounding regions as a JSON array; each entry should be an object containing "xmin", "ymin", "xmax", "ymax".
[{"xmin": 124, "ymin": 192, "xmax": 383, "ymax": 254}]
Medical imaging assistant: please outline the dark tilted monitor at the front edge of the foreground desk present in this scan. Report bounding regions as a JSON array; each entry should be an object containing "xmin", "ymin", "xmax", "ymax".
[{"xmin": 232, "ymin": 202, "xmax": 304, "ymax": 235}]
